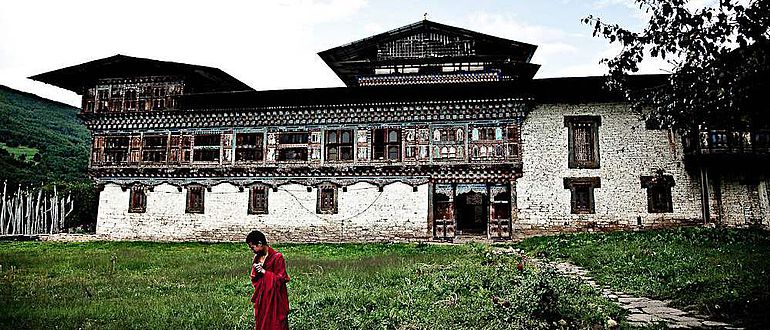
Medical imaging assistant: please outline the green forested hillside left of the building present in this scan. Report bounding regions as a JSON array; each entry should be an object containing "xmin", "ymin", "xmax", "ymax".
[{"xmin": 0, "ymin": 85, "xmax": 98, "ymax": 228}]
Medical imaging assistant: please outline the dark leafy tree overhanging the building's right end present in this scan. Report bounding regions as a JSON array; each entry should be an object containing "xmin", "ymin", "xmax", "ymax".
[{"xmin": 582, "ymin": 0, "xmax": 770, "ymax": 134}]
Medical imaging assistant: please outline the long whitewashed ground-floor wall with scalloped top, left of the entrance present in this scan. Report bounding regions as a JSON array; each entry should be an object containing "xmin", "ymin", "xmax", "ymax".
[{"xmin": 96, "ymin": 182, "xmax": 432, "ymax": 242}]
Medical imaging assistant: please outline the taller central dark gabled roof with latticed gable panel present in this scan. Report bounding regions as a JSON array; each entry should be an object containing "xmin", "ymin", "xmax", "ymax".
[{"xmin": 318, "ymin": 20, "xmax": 539, "ymax": 86}]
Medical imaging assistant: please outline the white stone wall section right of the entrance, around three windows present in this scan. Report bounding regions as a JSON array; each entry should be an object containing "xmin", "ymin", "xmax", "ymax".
[{"xmin": 515, "ymin": 103, "xmax": 701, "ymax": 231}]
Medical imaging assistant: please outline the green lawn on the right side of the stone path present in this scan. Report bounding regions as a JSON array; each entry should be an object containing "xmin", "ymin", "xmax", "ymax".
[{"xmin": 519, "ymin": 228, "xmax": 770, "ymax": 329}]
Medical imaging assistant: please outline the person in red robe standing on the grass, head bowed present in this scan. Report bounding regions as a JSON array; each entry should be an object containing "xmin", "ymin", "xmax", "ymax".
[{"xmin": 246, "ymin": 230, "xmax": 289, "ymax": 330}]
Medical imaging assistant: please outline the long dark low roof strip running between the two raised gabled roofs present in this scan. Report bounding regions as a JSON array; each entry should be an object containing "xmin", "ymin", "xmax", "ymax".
[{"xmin": 180, "ymin": 75, "xmax": 667, "ymax": 110}]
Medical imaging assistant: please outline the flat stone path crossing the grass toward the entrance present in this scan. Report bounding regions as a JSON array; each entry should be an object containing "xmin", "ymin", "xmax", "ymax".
[{"xmin": 495, "ymin": 247, "xmax": 742, "ymax": 329}]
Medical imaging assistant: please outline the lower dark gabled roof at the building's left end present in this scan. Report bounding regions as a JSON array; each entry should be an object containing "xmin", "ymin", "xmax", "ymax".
[{"xmin": 29, "ymin": 54, "xmax": 253, "ymax": 94}]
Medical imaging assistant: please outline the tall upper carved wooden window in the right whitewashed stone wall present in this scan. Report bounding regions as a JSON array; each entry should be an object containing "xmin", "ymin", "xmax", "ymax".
[{"xmin": 564, "ymin": 116, "xmax": 601, "ymax": 168}]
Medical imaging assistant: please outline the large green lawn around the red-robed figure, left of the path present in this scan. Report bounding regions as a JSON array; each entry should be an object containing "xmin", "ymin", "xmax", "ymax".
[{"xmin": 0, "ymin": 242, "xmax": 623, "ymax": 329}]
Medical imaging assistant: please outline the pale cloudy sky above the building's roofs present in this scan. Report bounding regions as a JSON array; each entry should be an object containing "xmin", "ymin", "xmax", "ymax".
[{"xmin": 0, "ymin": 0, "xmax": 662, "ymax": 106}]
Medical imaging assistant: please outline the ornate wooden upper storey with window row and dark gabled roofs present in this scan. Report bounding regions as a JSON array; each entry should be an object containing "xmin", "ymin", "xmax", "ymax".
[{"xmin": 32, "ymin": 21, "xmax": 664, "ymax": 186}]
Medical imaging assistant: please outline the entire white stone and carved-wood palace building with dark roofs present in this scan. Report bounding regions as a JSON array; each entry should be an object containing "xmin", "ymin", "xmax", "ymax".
[{"xmin": 31, "ymin": 20, "xmax": 770, "ymax": 242}]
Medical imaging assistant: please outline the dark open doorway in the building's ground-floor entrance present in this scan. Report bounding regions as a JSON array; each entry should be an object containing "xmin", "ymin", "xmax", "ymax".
[{"xmin": 455, "ymin": 191, "xmax": 489, "ymax": 234}]
